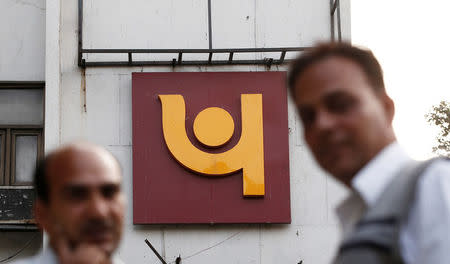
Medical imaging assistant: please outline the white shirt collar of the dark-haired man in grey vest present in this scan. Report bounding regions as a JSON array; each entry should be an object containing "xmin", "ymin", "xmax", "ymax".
[{"xmin": 351, "ymin": 141, "xmax": 412, "ymax": 207}]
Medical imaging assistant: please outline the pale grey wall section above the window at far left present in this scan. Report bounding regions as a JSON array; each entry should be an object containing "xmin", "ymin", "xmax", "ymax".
[{"xmin": 0, "ymin": 0, "xmax": 45, "ymax": 81}]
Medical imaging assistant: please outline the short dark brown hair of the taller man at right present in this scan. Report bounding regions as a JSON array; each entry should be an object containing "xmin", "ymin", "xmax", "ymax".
[{"xmin": 288, "ymin": 42, "xmax": 385, "ymax": 96}]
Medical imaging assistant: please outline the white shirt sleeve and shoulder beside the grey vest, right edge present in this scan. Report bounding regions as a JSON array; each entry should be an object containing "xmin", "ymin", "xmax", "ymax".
[{"xmin": 401, "ymin": 159, "xmax": 450, "ymax": 263}]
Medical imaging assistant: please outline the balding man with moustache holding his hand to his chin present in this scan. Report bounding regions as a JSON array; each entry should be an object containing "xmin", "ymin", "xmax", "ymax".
[{"xmin": 12, "ymin": 143, "xmax": 125, "ymax": 264}]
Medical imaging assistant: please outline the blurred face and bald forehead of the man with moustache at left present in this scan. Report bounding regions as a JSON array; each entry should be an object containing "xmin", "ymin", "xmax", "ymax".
[{"xmin": 36, "ymin": 147, "xmax": 125, "ymax": 256}]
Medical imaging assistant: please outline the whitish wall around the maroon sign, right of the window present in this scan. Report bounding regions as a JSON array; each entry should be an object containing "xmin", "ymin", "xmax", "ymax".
[{"xmin": 1, "ymin": 0, "xmax": 350, "ymax": 264}]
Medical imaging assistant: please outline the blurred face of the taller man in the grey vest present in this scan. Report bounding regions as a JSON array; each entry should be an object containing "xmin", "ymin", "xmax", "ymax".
[{"xmin": 295, "ymin": 56, "xmax": 394, "ymax": 185}]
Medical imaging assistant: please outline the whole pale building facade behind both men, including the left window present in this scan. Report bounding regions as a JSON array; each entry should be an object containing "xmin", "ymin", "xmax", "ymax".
[{"xmin": 0, "ymin": 0, "xmax": 350, "ymax": 264}]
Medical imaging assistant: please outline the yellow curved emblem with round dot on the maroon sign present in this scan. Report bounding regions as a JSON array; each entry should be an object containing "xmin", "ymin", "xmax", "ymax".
[{"xmin": 159, "ymin": 94, "xmax": 264, "ymax": 196}]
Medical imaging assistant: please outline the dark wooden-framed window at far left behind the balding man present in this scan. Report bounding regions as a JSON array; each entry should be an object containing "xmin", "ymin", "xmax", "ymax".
[{"xmin": 0, "ymin": 82, "xmax": 44, "ymax": 225}]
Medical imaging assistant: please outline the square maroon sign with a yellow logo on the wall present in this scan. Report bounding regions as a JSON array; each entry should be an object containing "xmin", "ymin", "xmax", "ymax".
[{"xmin": 132, "ymin": 72, "xmax": 290, "ymax": 224}]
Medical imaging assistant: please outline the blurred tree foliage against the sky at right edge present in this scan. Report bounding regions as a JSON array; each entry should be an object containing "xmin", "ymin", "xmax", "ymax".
[{"xmin": 425, "ymin": 101, "xmax": 450, "ymax": 157}]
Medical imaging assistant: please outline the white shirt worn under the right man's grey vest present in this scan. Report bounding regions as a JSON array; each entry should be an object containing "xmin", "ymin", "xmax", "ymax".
[{"xmin": 336, "ymin": 142, "xmax": 450, "ymax": 264}]
